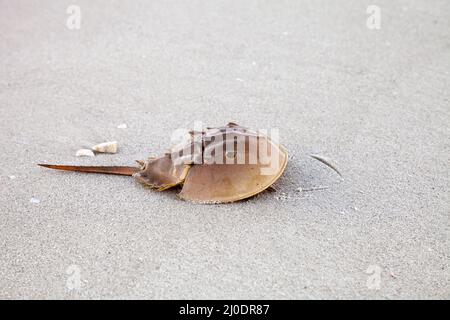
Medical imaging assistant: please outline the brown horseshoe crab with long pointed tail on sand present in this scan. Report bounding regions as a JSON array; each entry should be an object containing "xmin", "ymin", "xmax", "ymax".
[{"xmin": 40, "ymin": 123, "xmax": 288, "ymax": 203}]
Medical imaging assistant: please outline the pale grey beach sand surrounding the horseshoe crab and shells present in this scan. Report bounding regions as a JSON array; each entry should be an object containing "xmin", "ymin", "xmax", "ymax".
[{"xmin": 0, "ymin": 0, "xmax": 450, "ymax": 299}]
